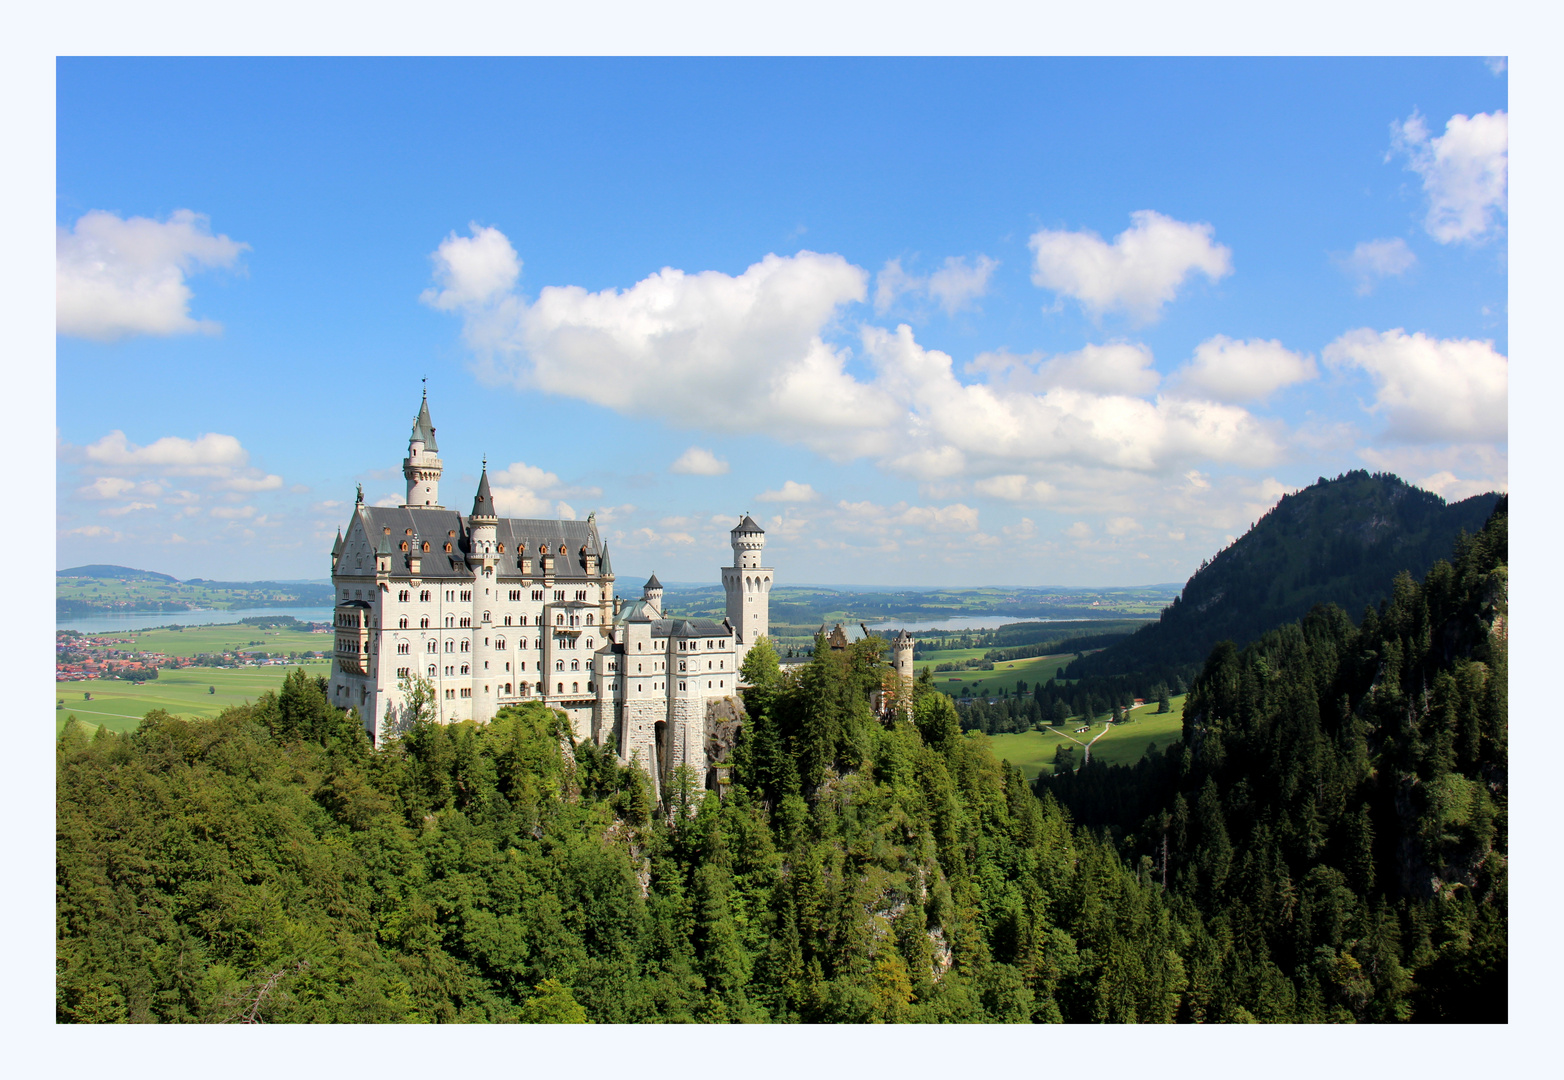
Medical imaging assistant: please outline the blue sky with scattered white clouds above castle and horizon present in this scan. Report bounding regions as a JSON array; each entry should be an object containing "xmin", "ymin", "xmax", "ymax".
[{"xmin": 55, "ymin": 58, "xmax": 1509, "ymax": 586}]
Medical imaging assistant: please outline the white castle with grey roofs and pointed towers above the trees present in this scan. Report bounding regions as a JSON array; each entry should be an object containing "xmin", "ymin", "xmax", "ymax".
[{"xmin": 330, "ymin": 392, "xmax": 772, "ymax": 791}]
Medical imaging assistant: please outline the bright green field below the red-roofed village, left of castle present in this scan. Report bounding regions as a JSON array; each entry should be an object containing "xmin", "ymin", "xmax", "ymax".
[{"xmin": 55, "ymin": 660, "xmax": 332, "ymax": 738}]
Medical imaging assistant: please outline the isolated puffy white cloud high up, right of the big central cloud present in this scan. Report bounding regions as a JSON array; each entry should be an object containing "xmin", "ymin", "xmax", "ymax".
[{"xmin": 1031, "ymin": 209, "xmax": 1232, "ymax": 322}]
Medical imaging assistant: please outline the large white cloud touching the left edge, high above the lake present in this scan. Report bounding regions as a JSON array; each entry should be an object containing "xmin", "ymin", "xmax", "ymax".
[{"xmin": 55, "ymin": 209, "xmax": 250, "ymax": 341}]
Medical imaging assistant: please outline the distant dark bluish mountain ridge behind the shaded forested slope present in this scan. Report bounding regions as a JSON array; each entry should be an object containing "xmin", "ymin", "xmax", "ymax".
[{"xmin": 1065, "ymin": 469, "xmax": 1500, "ymax": 678}]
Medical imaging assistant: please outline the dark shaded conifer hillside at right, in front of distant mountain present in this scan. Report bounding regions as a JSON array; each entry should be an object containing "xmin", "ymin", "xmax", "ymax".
[{"xmin": 1037, "ymin": 499, "xmax": 1509, "ymax": 1021}]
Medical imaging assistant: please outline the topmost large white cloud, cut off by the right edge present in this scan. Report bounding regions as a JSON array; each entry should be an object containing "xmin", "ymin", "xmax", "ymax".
[{"xmin": 1390, "ymin": 109, "xmax": 1509, "ymax": 244}]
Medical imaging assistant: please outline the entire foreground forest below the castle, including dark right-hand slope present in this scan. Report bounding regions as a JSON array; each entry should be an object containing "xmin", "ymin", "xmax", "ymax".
[{"xmin": 56, "ymin": 497, "xmax": 1508, "ymax": 1022}]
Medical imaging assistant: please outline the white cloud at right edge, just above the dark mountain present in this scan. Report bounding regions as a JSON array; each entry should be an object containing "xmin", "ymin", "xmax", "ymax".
[{"xmin": 1323, "ymin": 328, "xmax": 1509, "ymax": 442}]
